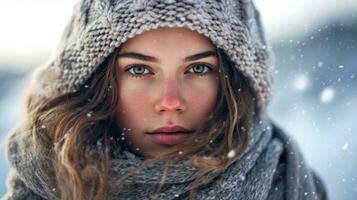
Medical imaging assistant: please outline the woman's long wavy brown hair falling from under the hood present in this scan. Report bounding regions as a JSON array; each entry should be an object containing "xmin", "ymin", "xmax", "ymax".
[{"xmin": 27, "ymin": 46, "xmax": 255, "ymax": 200}]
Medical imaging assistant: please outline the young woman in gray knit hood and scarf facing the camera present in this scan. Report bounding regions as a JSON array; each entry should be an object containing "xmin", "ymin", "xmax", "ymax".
[{"xmin": 4, "ymin": 0, "xmax": 327, "ymax": 200}]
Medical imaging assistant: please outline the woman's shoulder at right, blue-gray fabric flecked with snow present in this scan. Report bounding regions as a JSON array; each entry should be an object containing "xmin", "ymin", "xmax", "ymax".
[{"xmin": 268, "ymin": 122, "xmax": 328, "ymax": 200}]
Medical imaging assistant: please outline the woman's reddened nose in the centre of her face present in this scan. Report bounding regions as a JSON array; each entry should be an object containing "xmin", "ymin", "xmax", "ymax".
[{"xmin": 155, "ymin": 80, "xmax": 186, "ymax": 113}]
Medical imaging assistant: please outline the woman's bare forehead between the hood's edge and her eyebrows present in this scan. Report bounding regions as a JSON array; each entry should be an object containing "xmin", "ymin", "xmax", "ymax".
[{"xmin": 120, "ymin": 27, "xmax": 215, "ymax": 54}]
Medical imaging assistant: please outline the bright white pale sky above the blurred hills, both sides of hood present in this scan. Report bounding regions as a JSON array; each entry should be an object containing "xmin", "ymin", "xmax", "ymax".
[{"xmin": 0, "ymin": 0, "xmax": 357, "ymax": 70}]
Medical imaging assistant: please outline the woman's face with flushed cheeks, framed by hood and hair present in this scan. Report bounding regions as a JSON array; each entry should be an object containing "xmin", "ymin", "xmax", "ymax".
[{"xmin": 116, "ymin": 28, "xmax": 219, "ymax": 157}]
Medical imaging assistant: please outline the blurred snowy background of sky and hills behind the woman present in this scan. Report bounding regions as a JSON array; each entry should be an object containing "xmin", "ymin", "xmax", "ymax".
[{"xmin": 0, "ymin": 0, "xmax": 357, "ymax": 200}]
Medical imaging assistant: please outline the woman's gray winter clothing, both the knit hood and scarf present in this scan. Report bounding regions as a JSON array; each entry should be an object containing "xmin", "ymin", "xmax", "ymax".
[{"xmin": 3, "ymin": 0, "xmax": 327, "ymax": 200}]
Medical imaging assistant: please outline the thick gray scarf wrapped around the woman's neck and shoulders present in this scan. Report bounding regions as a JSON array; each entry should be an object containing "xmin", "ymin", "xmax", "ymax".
[{"xmin": 3, "ymin": 119, "xmax": 327, "ymax": 200}]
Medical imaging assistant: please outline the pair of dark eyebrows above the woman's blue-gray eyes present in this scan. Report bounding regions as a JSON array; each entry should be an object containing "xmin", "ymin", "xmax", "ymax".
[{"xmin": 118, "ymin": 51, "xmax": 218, "ymax": 62}]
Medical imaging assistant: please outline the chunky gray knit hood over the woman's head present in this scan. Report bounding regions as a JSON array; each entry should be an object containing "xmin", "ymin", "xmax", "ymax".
[{"xmin": 36, "ymin": 0, "xmax": 272, "ymax": 114}]
